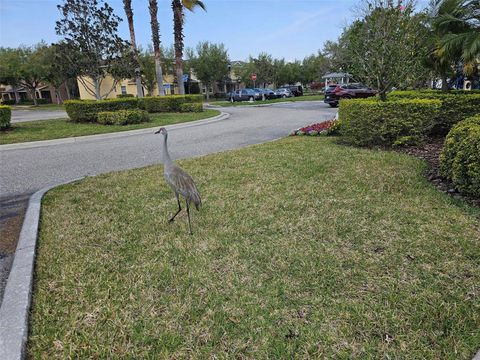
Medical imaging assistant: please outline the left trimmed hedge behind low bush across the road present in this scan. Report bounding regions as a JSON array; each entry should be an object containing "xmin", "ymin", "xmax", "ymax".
[{"xmin": 64, "ymin": 98, "xmax": 138, "ymax": 122}]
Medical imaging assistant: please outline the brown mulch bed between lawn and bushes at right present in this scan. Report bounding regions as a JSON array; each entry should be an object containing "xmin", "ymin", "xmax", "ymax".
[{"xmin": 396, "ymin": 138, "xmax": 480, "ymax": 207}]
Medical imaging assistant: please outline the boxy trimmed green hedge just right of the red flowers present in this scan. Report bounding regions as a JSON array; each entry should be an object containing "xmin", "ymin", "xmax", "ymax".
[{"xmin": 339, "ymin": 99, "xmax": 441, "ymax": 146}]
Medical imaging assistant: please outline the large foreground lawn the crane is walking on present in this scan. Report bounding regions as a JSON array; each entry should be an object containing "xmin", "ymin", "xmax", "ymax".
[{"xmin": 28, "ymin": 137, "xmax": 480, "ymax": 360}]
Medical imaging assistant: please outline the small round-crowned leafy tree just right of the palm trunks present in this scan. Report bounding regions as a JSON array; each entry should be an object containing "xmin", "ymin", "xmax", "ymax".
[{"xmin": 190, "ymin": 41, "xmax": 229, "ymax": 100}]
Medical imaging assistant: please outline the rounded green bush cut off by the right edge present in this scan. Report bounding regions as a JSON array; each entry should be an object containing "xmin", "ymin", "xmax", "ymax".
[{"xmin": 440, "ymin": 115, "xmax": 480, "ymax": 196}]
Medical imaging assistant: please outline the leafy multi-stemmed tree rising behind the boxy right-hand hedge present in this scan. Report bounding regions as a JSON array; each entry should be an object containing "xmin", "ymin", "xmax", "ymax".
[{"xmin": 341, "ymin": 0, "xmax": 427, "ymax": 100}]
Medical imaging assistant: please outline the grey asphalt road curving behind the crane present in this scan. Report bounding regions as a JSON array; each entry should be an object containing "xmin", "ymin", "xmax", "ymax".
[{"xmin": 0, "ymin": 102, "xmax": 336, "ymax": 197}]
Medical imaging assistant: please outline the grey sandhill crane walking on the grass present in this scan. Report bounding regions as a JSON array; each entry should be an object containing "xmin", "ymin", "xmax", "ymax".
[{"xmin": 155, "ymin": 127, "xmax": 202, "ymax": 235}]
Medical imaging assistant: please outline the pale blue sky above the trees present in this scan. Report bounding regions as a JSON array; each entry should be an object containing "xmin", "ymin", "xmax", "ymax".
[{"xmin": 0, "ymin": 0, "xmax": 361, "ymax": 61}]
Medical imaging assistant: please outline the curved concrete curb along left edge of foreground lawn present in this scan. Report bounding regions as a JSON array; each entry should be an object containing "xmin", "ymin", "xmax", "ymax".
[{"xmin": 0, "ymin": 178, "xmax": 83, "ymax": 360}]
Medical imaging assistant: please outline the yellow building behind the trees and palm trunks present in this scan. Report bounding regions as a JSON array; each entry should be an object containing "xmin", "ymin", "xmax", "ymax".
[{"xmin": 77, "ymin": 75, "xmax": 178, "ymax": 100}]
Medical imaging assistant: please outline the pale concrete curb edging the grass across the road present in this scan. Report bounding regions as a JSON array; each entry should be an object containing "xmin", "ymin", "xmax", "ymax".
[{"xmin": 0, "ymin": 111, "xmax": 230, "ymax": 152}]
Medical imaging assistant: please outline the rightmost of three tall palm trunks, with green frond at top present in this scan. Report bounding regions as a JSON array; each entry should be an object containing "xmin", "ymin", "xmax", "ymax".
[{"xmin": 172, "ymin": 0, "xmax": 206, "ymax": 95}]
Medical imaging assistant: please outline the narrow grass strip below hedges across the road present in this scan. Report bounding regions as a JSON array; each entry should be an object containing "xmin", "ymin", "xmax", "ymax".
[{"xmin": 0, "ymin": 110, "xmax": 220, "ymax": 144}]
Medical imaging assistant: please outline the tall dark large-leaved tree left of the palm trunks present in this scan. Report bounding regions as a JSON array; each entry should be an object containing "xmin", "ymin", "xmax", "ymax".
[{"xmin": 55, "ymin": 0, "xmax": 135, "ymax": 99}]
